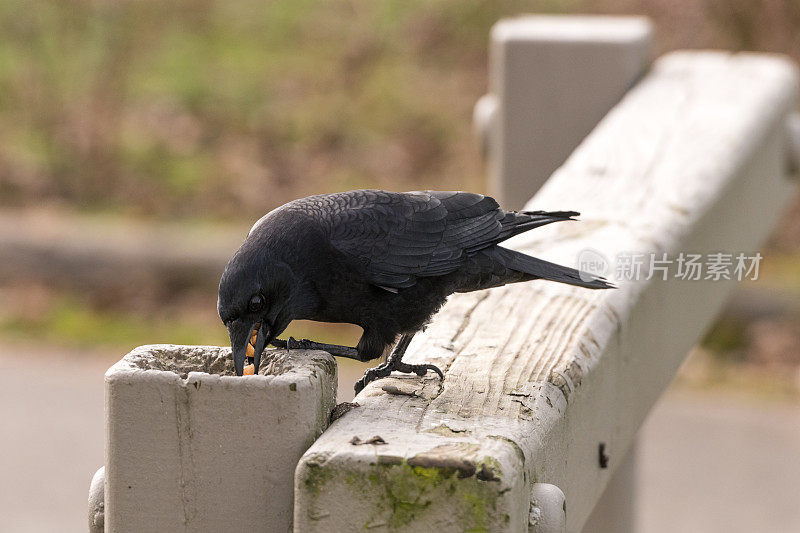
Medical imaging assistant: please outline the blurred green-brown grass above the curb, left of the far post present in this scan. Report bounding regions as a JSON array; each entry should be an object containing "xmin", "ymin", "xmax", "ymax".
[{"xmin": 0, "ymin": 0, "xmax": 568, "ymax": 217}]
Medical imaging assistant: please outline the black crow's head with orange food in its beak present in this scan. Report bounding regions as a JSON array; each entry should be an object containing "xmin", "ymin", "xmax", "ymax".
[{"xmin": 217, "ymin": 247, "xmax": 297, "ymax": 376}]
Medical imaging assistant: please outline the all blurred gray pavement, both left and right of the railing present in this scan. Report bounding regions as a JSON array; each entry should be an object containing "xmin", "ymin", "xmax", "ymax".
[{"xmin": 0, "ymin": 344, "xmax": 800, "ymax": 533}]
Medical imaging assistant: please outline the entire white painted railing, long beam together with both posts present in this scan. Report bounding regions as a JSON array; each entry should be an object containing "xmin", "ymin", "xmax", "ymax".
[{"xmin": 90, "ymin": 17, "xmax": 800, "ymax": 533}]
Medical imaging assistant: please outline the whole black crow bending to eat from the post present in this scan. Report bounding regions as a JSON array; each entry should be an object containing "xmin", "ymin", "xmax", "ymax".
[{"xmin": 217, "ymin": 190, "xmax": 611, "ymax": 392}]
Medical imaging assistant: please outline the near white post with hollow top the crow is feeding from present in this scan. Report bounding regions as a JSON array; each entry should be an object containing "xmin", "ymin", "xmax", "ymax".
[{"xmin": 105, "ymin": 345, "xmax": 336, "ymax": 532}]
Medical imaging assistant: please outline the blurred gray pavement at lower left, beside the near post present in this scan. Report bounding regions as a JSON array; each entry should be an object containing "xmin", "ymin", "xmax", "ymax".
[{"xmin": 0, "ymin": 344, "xmax": 119, "ymax": 533}]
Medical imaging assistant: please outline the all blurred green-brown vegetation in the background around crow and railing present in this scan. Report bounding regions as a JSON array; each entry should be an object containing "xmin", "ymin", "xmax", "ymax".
[{"xmin": 0, "ymin": 0, "xmax": 800, "ymax": 390}]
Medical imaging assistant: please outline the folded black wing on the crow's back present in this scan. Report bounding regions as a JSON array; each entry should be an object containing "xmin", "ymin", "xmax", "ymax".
[{"xmin": 304, "ymin": 190, "xmax": 577, "ymax": 289}]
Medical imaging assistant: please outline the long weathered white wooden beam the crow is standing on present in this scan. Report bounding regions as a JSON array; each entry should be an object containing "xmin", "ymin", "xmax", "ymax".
[{"xmin": 295, "ymin": 52, "xmax": 798, "ymax": 531}]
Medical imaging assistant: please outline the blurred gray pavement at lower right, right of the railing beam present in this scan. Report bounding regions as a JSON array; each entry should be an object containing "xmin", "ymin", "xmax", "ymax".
[{"xmin": 638, "ymin": 393, "xmax": 800, "ymax": 533}]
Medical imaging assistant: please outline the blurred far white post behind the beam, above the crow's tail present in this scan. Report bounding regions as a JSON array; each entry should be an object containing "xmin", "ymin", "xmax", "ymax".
[{"xmin": 474, "ymin": 15, "xmax": 652, "ymax": 209}]
